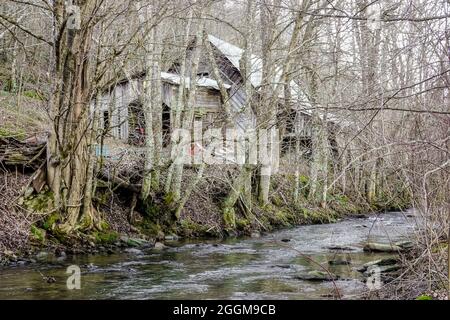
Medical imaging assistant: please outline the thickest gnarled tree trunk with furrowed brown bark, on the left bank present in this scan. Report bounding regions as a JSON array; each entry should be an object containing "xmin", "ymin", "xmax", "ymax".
[{"xmin": 47, "ymin": 0, "xmax": 103, "ymax": 233}]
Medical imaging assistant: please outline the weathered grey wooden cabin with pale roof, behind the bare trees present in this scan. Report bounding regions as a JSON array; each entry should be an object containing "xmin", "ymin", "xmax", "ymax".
[{"xmin": 99, "ymin": 35, "xmax": 344, "ymax": 156}]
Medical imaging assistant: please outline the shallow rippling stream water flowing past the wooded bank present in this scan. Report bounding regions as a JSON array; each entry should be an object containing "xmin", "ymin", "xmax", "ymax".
[{"xmin": 0, "ymin": 212, "xmax": 416, "ymax": 300}]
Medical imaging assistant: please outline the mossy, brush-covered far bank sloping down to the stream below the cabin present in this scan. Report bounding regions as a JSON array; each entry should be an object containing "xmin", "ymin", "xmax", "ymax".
[{"xmin": 0, "ymin": 166, "xmax": 410, "ymax": 264}]
